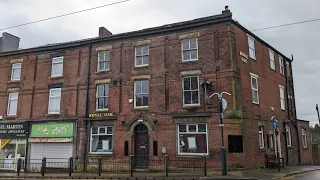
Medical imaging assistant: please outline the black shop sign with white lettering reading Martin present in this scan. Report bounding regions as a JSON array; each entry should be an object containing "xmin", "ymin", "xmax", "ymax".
[{"xmin": 0, "ymin": 122, "xmax": 28, "ymax": 139}]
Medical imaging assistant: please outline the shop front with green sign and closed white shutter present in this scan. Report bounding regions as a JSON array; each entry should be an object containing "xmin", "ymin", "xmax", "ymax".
[{"xmin": 29, "ymin": 123, "xmax": 74, "ymax": 164}]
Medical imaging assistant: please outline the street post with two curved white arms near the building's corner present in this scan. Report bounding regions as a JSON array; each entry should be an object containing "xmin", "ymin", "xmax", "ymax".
[{"xmin": 209, "ymin": 92, "xmax": 231, "ymax": 176}]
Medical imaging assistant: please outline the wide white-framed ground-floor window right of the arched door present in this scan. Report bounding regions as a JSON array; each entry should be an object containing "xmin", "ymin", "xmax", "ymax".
[{"xmin": 177, "ymin": 124, "xmax": 208, "ymax": 154}]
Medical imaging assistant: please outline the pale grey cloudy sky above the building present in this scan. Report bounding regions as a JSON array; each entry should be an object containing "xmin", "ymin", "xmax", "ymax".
[{"xmin": 0, "ymin": 0, "xmax": 320, "ymax": 125}]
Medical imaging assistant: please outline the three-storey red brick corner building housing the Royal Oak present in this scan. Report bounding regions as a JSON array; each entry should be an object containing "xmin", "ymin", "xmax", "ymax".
[{"xmin": 0, "ymin": 5, "xmax": 312, "ymax": 167}]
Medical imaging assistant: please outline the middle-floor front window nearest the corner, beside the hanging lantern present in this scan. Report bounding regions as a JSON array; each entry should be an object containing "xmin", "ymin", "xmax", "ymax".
[{"xmin": 182, "ymin": 76, "xmax": 200, "ymax": 106}]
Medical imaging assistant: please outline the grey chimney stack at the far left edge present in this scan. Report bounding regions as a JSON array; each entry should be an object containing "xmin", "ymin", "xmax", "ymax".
[{"xmin": 0, "ymin": 32, "xmax": 20, "ymax": 53}]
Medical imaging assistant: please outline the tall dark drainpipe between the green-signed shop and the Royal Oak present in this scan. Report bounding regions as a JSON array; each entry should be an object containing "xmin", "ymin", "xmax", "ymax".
[{"xmin": 83, "ymin": 43, "xmax": 92, "ymax": 172}]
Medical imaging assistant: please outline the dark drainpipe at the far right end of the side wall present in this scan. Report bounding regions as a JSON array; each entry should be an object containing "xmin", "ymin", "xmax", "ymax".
[{"xmin": 289, "ymin": 55, "xmax": 301, "ymax": 165}]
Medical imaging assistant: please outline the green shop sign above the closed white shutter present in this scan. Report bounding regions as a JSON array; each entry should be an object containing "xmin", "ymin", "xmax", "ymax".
[{"xmin": 31, "ymin": 123, "xmax": 73, "ymax": 137}]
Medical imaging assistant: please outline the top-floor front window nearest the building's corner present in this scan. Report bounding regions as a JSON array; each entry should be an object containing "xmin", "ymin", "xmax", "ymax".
[{"xmin": 182, "ymin": 38, "xmax": 198, "ymax": 61}]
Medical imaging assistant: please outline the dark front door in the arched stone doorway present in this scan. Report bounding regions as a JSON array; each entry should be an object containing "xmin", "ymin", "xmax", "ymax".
[{"xmin": 134, "ymin": 124, "xmax": 149, "ymax": 169}]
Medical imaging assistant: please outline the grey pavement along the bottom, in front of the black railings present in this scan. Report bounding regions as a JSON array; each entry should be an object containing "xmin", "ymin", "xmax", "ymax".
[{"xmin": 0, "ymin": 165, "xmax": 320, "ymax": 180}]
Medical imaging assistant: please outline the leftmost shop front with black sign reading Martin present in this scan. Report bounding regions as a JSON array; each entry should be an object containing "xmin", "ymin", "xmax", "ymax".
[{"xmin": 0, "ymin": 122, "xmax": 28, "ymax": 170}]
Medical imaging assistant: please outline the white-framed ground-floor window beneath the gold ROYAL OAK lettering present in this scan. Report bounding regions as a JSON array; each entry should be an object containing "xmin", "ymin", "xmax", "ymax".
[{"xmin": 90, "ymin": 126, "xmax": 113, "ymax": 154}]
